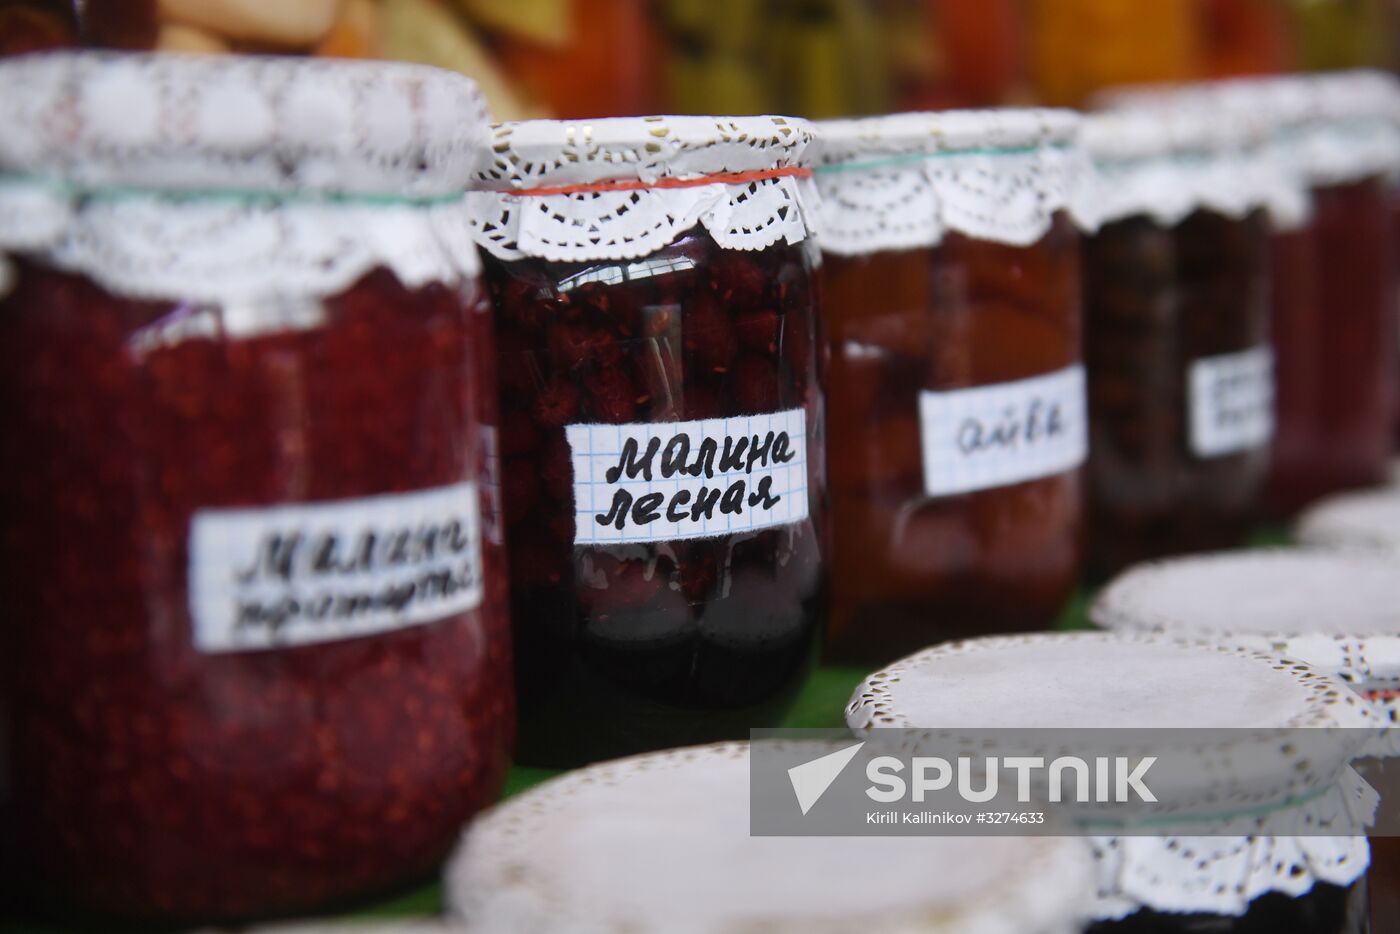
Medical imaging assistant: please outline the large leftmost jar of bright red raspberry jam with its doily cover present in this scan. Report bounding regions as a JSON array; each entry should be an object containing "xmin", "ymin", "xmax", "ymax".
[{"xmin": 0, "ymin": 53, "xmax": 514, "ymax": 923}]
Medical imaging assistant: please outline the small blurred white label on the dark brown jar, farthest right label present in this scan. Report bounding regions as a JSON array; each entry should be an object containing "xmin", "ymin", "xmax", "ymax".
[{"xmin": 1190, "ymin": 347, "xmax": 1274, "ymax": 458}]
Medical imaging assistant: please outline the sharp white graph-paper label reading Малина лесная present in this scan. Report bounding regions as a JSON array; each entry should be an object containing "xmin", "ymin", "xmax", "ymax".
[{"xmin": 567, "ymin": 409, "xmax": 808, "ymax": 545}]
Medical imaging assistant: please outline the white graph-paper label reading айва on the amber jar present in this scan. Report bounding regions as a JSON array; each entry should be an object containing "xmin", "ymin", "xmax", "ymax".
[{"xmin": 918, "ymin": 367, "xmax": 1089, "ymax": 496}]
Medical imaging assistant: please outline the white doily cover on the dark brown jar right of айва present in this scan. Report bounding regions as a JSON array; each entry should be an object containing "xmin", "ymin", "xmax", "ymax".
[{"xmin": 1081, "ymin": 105, "xmax": 1310, "ymax": 228}]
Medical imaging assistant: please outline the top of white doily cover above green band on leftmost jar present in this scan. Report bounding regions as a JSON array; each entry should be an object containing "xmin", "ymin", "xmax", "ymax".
[{"xmin": 0, "ymin": 52, "xmax": 489, "ymax": 199}]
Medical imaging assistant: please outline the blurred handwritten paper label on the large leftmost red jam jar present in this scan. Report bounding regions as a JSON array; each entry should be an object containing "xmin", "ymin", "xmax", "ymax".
[{"xmin": 189, "ymin": 483, "xmax": 482, "ymax": 653}]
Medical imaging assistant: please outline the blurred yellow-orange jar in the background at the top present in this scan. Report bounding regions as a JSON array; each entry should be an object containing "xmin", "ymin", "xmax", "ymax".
[{"xmin": 1026, "ymin": 0, "xmax": 1203, "ymax": 106}]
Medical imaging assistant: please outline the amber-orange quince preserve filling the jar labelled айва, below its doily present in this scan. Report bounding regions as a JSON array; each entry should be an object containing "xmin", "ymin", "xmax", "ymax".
[{"xmin": 823, "ymin": 217, "xmax": 1082, "ymax": 662}]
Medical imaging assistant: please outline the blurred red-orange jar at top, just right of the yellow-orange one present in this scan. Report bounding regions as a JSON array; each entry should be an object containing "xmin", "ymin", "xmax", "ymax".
[{"xmin": 1201, "ymin": 0, "xmax": 1298, "ymax": 77}]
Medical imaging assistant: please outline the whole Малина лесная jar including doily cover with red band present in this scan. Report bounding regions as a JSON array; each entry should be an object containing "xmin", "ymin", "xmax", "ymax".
[{"xmin": 473, "ymin": 116, "xmax": 826, "ymax": 765}]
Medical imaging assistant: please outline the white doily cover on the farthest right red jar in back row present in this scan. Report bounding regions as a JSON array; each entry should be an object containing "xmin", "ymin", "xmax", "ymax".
[{"xmin": 1100, "ymin": 70, "xmax": 1400, "ymax": 228}]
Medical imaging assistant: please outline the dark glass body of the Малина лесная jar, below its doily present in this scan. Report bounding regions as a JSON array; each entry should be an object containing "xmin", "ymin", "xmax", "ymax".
[{"xmin": 486, "ymin": 230, "xmax": 826, "ymax": 765}]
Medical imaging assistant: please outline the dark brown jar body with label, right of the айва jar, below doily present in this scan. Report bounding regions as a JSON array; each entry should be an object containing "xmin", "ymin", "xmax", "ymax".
[{"xmin": 1085, "ymin": 210, "xmax": 1273, "ymax": 573}]
